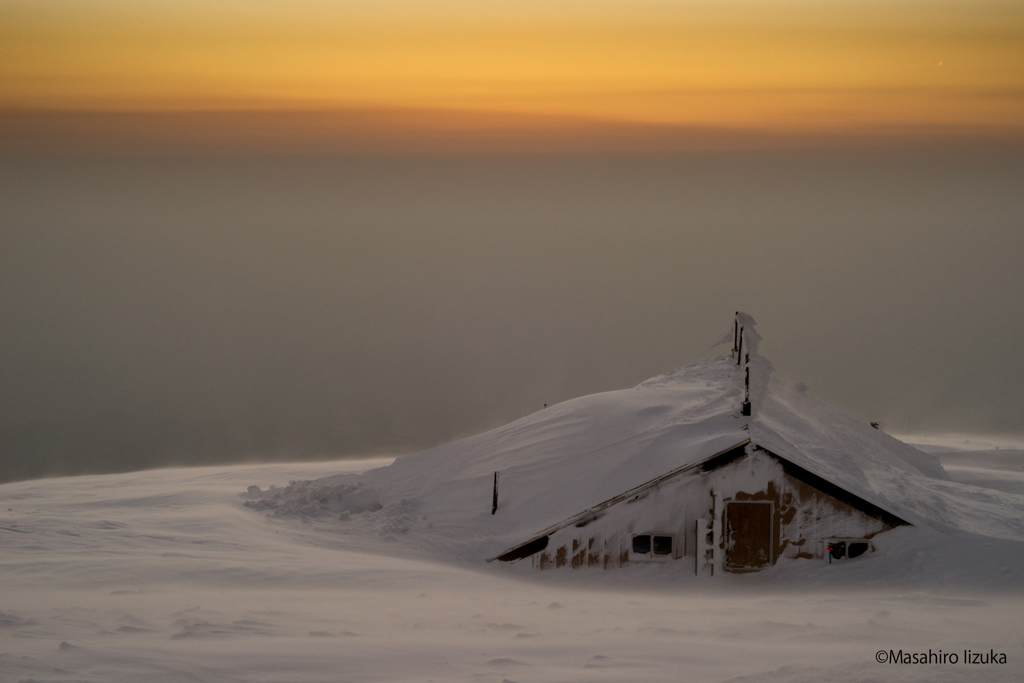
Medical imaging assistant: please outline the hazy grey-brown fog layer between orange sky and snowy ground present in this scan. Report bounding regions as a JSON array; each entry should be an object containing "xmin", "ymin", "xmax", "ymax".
[{"xmin": 0, "ymin": 150, "xmax": 1024, "ymax": 481}]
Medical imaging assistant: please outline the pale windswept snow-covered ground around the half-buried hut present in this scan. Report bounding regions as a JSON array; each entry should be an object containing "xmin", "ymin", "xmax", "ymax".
[{"xmin": 0, "ymin": 444, "xmax": 1024, "ymax": 683}]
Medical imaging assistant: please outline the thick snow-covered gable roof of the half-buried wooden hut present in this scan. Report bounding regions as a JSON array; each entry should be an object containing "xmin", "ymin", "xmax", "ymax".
[{"xmin": 337, "ymin": 321, "xmax": 948, "ymax": 553}]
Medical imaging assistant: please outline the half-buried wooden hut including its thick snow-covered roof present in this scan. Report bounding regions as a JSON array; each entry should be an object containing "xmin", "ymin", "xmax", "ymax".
[{"xmin": 331, "ymin": 313, "xmax": 948, "ymax": 573}]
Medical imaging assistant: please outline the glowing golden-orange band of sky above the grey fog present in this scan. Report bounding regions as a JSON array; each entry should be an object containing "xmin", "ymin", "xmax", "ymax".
[{"xmin": 0, "ymin": 0, "xmax": 1024, "ymax": 150}]
